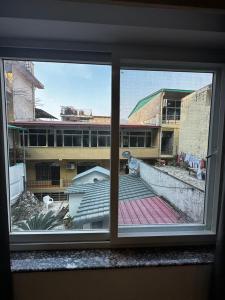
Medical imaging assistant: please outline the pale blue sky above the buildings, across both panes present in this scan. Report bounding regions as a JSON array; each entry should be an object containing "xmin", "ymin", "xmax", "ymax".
[{"xmin": 34, "ymin": 62, "xmax": 212, "ymax": 120}]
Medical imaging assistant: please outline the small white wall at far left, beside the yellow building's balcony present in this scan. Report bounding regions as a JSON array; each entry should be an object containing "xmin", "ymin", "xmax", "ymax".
[{"xmin": 9, "ymin": 163, "xmax": 26, "ymax": 205}]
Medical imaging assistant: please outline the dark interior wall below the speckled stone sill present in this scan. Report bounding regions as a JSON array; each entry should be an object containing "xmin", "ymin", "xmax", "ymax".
[{"xmin": 13, "ymin": 265, "xmax": 212, "ymax": 300}]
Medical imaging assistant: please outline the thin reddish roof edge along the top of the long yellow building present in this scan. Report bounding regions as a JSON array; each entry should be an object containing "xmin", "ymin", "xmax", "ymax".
[{"xmin": 10, "ymin": 120, "xmax": 160, "ymax": 129}]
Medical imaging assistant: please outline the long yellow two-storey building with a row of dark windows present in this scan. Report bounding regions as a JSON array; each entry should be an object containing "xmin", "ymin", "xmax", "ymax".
[{"xmin": 12, "ymin": 121, "xmax": 160, "ymax": 197}]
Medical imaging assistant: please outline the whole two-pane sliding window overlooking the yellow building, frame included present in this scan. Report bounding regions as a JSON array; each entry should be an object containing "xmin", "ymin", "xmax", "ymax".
[{"xmin": 1, "ymin": 55, "xmax": 223, "ymax": 247}]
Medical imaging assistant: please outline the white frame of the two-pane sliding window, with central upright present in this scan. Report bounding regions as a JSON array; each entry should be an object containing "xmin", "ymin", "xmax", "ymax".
[{"xmin": 0, "ymin": 49, "xmax": 225, "ymax": 250}]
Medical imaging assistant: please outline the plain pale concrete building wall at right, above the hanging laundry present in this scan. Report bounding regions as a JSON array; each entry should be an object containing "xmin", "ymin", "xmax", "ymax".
[{"xmin": 179, "ymin": 85, "xmax": 212, "ymax": 159}]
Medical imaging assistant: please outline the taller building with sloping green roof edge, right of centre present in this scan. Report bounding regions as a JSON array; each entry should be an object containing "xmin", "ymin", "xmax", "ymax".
[{"xmin": 128, "ymin": 89, "xmax": 193, "ymax": 157}]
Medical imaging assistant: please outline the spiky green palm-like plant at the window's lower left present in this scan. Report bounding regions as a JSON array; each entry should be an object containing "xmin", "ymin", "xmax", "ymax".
[{"xmin": 14, "ymin": 210, "xmax": 62, "ymax": 230}]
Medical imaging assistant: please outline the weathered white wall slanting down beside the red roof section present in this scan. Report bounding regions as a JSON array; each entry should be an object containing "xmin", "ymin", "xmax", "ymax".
[{"xmin": 140, "ymin": 161, "xmax": 205, "ymax": 223}]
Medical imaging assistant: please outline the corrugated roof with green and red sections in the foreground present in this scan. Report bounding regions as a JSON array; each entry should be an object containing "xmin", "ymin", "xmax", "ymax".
[{"xmin": 66, "ymin": 174, "xmax": 188, "ymax": 225}]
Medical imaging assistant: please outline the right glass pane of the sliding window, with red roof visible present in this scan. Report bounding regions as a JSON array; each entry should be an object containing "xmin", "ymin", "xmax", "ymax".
[{"xmin": 118, "ymin": 69, "xmax": 213, "ymax": 233}]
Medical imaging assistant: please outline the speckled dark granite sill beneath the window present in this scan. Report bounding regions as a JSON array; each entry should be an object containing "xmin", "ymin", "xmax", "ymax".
[{"xmin": 11, "ymin": 247, "xmax": 214, "ymax": 272}]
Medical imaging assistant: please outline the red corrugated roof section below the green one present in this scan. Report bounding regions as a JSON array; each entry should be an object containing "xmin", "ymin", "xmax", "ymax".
[{"xmin": 119, "ymin": 196, "xmax": 187, "ymax": 225}]
